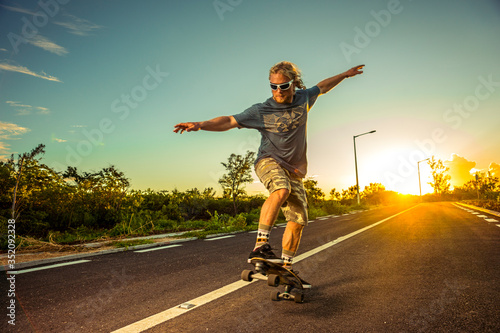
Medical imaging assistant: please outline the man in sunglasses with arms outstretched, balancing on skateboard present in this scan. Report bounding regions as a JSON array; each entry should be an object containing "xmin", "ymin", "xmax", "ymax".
[{"xmin": 174, "ymin": 61, "xmax": 364, "ymax": 282}]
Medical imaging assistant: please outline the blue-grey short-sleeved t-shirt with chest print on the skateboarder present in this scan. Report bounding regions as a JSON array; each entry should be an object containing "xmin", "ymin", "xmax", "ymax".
[{"xmin": 233, "ymin": 86, "xmax": 320, "ymax": 177}]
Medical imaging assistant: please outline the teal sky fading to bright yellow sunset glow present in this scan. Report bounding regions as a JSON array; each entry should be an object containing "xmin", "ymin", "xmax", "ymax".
[{"xmin": 0, "ymin": 0, "xmax": 500, "ymax": 195}]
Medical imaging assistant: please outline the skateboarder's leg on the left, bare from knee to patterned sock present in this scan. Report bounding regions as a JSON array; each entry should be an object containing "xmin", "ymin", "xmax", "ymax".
[{"xmin": 254, "ymin": 188, "xmax": 290, "ymax": 250}]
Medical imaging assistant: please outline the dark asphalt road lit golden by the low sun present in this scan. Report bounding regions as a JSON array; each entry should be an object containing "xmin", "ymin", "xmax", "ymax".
[{"xmin": 0, "ymin": 203, "xmax": 500, "ymax": 332}]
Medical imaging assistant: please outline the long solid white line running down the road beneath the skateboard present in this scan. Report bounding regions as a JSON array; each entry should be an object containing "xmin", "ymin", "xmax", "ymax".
[{"xmin": 112, "ymin": 206, "xmax": 417, "ymax": 333}]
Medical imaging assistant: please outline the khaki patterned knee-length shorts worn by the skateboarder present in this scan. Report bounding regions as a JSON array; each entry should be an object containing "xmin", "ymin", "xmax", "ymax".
[{"xmin": 255, "ymin": 157, "xmax": 308, "ymax": 226}]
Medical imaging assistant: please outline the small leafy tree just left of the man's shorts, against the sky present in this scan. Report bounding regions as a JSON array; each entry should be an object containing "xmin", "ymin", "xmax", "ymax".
[{"xmin": 219, "ymin": 151, "xmax": 255, "ymax": 215}]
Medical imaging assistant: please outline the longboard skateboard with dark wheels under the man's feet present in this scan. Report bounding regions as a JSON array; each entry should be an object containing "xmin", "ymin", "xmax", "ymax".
[{"xmin": 241, "ymin": 258, "xmax": 307, "ymax": 303}]
